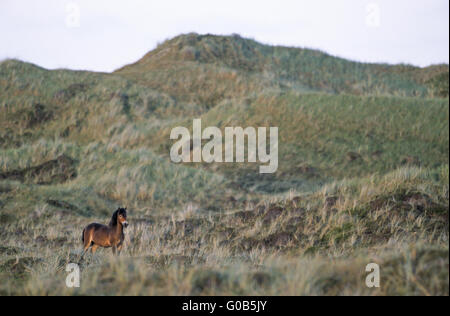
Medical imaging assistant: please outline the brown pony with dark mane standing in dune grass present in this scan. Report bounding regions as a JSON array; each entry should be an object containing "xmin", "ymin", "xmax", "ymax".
[{"xmin": 81, "ymin": 207, "xmax": 128, "ymax": 258}]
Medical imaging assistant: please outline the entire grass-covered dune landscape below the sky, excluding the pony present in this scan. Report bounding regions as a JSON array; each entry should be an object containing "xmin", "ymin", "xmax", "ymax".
[{"xmin": 0, "ymin": 34, "xmax": 449, "ymax": 295}]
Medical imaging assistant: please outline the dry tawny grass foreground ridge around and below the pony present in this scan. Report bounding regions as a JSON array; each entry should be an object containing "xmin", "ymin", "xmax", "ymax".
[{"xmin": 0, "ymin": 167, "xmax": 448, "ymax": 295}]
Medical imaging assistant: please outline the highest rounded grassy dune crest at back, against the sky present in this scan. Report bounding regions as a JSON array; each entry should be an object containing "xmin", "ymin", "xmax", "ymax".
[{"xmin": 116, "ymin": 34, "xmax": 449, "ymax": 100}]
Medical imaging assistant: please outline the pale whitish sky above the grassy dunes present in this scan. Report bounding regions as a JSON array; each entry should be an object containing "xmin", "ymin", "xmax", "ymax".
[{"xmin": 0, "ymin": 0, "xmax": 449, "ymax": 71}]
